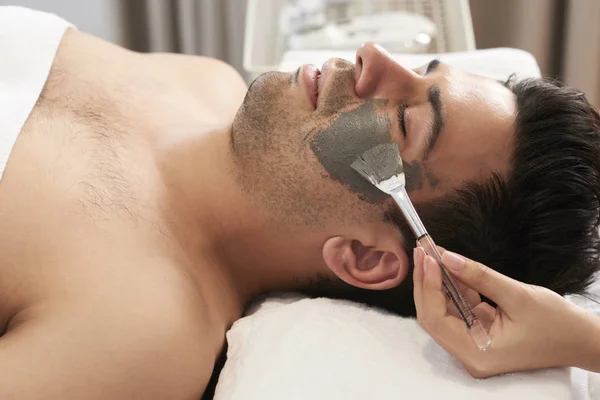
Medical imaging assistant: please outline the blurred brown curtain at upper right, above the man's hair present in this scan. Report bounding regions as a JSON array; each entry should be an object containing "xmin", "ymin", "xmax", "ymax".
[{"xmin": 470, "ymin": 0, "xmax": 600, "ymax": 106}]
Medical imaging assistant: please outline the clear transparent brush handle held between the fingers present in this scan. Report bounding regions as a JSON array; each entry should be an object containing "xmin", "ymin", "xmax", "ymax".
[{"xmin": 417, "ymin": 234, "xmax": 491, "ymax": 350}]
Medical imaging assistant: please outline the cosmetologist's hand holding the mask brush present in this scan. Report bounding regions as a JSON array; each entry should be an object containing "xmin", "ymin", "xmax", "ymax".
[{"xmin": 413, "ymin": 248, "xmax": 600, "ymax": 378}]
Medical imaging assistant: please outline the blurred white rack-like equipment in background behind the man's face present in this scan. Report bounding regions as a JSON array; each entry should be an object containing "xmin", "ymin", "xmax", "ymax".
[{"xmin": 244, "ymin": 0, "xmax": 475, "ymax": 79}]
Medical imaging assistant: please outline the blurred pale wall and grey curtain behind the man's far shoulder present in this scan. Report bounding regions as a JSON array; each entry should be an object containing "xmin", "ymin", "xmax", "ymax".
[{"xmin": 0, "ymin": 0, "xmax": 246, "ymax": 72}]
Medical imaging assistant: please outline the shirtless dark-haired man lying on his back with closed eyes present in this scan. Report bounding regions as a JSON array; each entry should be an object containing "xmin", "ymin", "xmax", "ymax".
[{"xmin": 0, "ymin": 7, "xmax": 600, "ymax": 400}]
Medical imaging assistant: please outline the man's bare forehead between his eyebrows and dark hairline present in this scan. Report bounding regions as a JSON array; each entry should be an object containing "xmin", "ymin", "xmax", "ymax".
[{"xmin": 414, "ymin": 68, "xmax": 516, "ymax": 203}]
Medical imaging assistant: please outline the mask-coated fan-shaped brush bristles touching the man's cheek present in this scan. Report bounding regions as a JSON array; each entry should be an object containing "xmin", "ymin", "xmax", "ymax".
[{"xmin": 351, "ymin": 143, "xmax": 403, "ymax": 193}]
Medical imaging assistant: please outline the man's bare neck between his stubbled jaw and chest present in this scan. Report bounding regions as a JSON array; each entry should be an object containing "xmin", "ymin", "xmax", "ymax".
[{"xmin": 159, "ymin": 129, "xmax": 323, "ymax": 324}]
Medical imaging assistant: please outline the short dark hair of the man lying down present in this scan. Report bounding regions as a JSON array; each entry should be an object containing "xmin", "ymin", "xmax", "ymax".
[{"xmin": 302, "ymin": 79, "xmax": 600, "ymax": 315}]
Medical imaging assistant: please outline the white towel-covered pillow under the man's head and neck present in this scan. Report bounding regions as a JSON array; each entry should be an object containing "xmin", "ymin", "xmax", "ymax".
[{"xmin": 215, "ymin": 295, "xmax": 598, "ymax": 400}]
